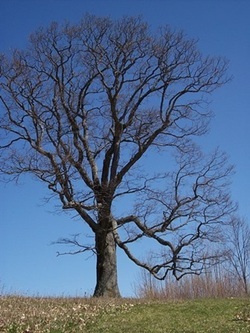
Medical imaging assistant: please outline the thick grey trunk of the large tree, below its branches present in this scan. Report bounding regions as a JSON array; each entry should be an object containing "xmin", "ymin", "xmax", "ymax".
[{"xmin": 94, "ymin": 228, "xmax": 120, "ymax": 297}]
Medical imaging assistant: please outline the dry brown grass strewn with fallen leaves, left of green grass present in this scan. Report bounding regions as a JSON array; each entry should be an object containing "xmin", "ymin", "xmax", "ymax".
[{"xmin": 0, "ymin": 296, "xmax": 136, "ymax": 333}]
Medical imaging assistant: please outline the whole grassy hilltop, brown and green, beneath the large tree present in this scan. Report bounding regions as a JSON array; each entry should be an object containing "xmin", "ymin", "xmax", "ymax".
[{"xmin": 0, "ymin": 296, "xmax": 250, "ymax": 333}]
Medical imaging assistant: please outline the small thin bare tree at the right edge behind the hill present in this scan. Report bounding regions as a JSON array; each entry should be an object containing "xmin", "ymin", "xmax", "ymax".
[{"xmin": 226, "ymin": 217, "xmax": 250, "ymax": 295}]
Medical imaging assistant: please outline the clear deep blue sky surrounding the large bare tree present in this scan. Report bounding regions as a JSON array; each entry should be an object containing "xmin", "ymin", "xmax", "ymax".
[{"xmin": 0, "ymin": 0, "xmax": 250, "ymax": 296}]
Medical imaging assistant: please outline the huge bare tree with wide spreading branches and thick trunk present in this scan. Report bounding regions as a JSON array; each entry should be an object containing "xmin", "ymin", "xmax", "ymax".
[{"xmin": 0, "ymin": 15, "xmax": 234, "ymax": 297}]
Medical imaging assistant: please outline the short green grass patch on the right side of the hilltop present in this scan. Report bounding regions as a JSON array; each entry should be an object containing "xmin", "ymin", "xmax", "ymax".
[{"xmin": 87, "ymin": 299, "xmax": 250, "ymax": 333}]
